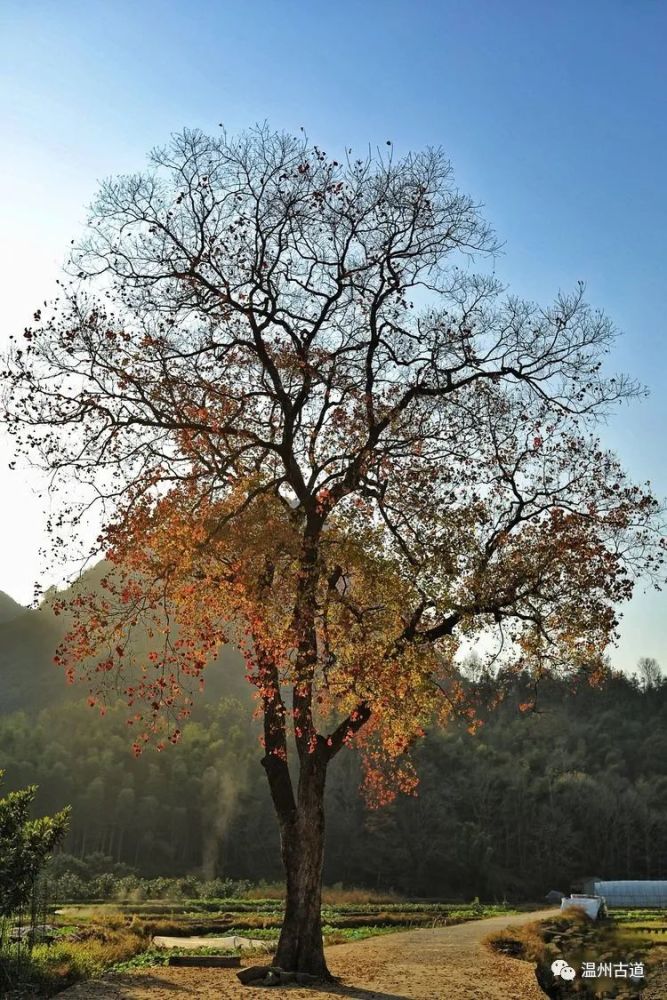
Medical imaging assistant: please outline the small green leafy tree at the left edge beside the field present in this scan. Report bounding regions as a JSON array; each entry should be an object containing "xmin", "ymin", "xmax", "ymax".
[{"xmin": 0, "ymin": 771, "xmax": 69, "ymax": 917}]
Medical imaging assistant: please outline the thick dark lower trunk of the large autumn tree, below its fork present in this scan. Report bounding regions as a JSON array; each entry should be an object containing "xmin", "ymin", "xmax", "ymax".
[{"xmin": 275, "ymin": 746, "xmax": 332, "ymax": 979}]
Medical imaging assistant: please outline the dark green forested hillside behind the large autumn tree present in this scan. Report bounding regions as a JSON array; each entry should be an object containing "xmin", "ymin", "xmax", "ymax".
[{"xmin": 0, "ymin": 584, "xmax": 667, "ymax": 899}]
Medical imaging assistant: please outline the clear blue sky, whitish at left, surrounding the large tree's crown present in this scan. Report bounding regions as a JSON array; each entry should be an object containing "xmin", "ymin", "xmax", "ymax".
[{"xmin": 0, "ymin": 0, "xmax": 667, "ymax": 670}]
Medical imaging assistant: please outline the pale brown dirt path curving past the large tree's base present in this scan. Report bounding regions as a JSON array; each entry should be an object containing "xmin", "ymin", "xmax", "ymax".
[{"xmin": 60, "ymin": 910, "xmax": 553, "ymax": 1000}]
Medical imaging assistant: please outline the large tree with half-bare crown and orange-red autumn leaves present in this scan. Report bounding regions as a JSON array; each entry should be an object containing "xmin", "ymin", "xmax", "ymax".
[{"xmin": 6, "ymin": 126, "xmax": 663, "ymax": 976}]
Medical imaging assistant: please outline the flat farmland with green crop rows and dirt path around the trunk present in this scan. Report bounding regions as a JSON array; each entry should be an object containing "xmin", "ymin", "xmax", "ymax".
[{"xmin": 2, "ymin": 890, "xmax": 667, "ymax": 1000}]
